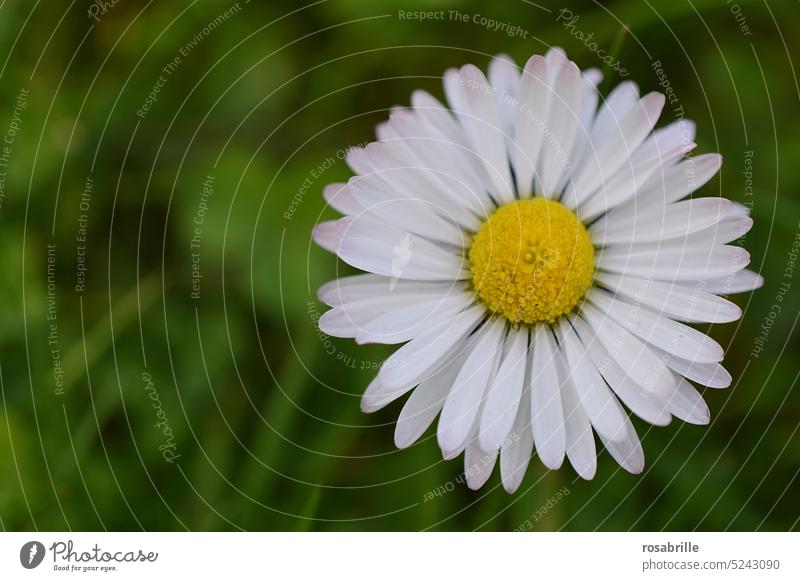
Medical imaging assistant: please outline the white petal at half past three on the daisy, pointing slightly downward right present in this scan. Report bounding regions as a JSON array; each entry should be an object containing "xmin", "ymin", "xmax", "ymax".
[{"xmin": 596, "ymin": 272, "xmax": 742, "ymax": 323}]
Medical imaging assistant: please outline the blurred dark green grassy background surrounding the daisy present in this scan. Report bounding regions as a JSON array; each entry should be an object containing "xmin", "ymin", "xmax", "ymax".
[{"xmin": 0, "ymin": 0, "xmax": 800, "ymax": 530}]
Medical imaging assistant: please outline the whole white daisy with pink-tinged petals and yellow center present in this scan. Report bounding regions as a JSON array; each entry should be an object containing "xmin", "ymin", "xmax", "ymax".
[{"xmin": 314, "ymin": 49, "xmax": 763, "ymax": 492}]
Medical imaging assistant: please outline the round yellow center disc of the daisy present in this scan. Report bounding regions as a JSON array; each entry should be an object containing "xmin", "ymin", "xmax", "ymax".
[{"xmin": 469, "ymin": 198, "xmax": 594, "ymax": 324}]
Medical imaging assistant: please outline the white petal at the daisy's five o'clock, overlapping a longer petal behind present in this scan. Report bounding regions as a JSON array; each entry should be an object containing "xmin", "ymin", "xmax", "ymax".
[{"xmin": 556, "ymin": 319, "xmax": 625, "ymax": 440}]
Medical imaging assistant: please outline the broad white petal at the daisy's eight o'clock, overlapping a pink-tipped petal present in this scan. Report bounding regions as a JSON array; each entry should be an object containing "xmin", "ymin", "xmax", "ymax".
[{"xmin": 378, "ymin": 307, "xmax": 485, "ymax": 388}]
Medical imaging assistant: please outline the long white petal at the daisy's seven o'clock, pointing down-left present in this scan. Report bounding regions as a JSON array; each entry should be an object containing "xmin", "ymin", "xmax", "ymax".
[{"xmin": 436, "ymin": 320, "xmax": 505, "ymax": 458}]
